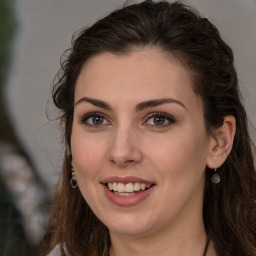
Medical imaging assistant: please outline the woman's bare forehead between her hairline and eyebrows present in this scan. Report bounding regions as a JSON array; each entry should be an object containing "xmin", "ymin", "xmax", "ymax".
[{"xmin": 75, "ymin": 48, "xmax": 196, "ymax": 107}]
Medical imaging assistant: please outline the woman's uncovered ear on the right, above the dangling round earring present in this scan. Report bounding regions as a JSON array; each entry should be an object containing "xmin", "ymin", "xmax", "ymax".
[{"xmin": 206, "ymin": 116, "xmax": 236, "ymax": 169}]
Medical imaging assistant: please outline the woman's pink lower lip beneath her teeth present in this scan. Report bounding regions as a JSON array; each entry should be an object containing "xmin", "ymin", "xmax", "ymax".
[{"xmin": 103, "ymin": 185, "xmax": 154, "ymax": 206}]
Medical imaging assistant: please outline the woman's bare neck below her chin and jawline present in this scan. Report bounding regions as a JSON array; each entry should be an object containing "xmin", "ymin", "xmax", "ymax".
[{"xmin": 110, "ymin": 210, "xmax": 207, "ymax": 256}]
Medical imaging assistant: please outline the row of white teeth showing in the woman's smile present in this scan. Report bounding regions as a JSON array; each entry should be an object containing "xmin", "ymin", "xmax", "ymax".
[{"xmin": 107, "ymin": 182, "xmax": 152, "ymax": 195}]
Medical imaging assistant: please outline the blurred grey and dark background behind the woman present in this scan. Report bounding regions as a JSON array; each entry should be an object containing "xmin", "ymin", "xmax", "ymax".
[{"xmin": 0, "ymin": 0, "xmax": 256, "ymax": 256}]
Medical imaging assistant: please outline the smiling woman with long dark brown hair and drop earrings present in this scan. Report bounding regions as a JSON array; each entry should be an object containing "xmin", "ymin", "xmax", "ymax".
[{"xmin": 40, "ymin": 1, "xmax": 256, "ymax": 256}]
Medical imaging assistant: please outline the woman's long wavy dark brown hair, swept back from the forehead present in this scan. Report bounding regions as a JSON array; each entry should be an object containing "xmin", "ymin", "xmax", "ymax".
[{"xmin": 39, "ymin": 1, "xmax": 256, "ymax": 256}]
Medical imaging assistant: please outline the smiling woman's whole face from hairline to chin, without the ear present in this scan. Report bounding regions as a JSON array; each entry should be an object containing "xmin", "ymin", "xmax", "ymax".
[{"xmin": 71, "ymin": 48, "xmax": 214, "ymax": 239}]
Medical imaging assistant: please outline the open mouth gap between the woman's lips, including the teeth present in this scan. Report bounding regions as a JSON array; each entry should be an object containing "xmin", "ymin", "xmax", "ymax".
[{"xmin": 104, "ymin": 182, "xmax": 154, "ymax": 196}]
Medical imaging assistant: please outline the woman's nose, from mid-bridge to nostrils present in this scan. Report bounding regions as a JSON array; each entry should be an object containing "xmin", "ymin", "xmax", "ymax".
[{"xmin": 109, "ymin": 127, "xmax": 143, "ymax": 168}]
